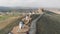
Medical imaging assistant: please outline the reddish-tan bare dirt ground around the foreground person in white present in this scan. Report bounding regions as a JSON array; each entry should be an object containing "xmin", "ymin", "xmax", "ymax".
[{"xmin": 11, "ymin": 25, "xmax": 29, "ymax": 34}]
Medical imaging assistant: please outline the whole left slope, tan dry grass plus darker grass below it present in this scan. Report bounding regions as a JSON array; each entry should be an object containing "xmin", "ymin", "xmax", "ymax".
[{"xmin": 0, "ymin": 17, "xmax": 21, "ymax": 34}]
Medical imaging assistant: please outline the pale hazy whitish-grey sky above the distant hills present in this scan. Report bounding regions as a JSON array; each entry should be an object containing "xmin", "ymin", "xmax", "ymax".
[{"xmin": 0, "ymin": 0, "xmax": 60, "ymax": 8}]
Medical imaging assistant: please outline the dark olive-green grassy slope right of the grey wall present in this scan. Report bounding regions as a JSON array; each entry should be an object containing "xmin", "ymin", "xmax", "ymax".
[{"xmin": 36, "ymin": 13, "xmax": 60, "ymax": 34}]
